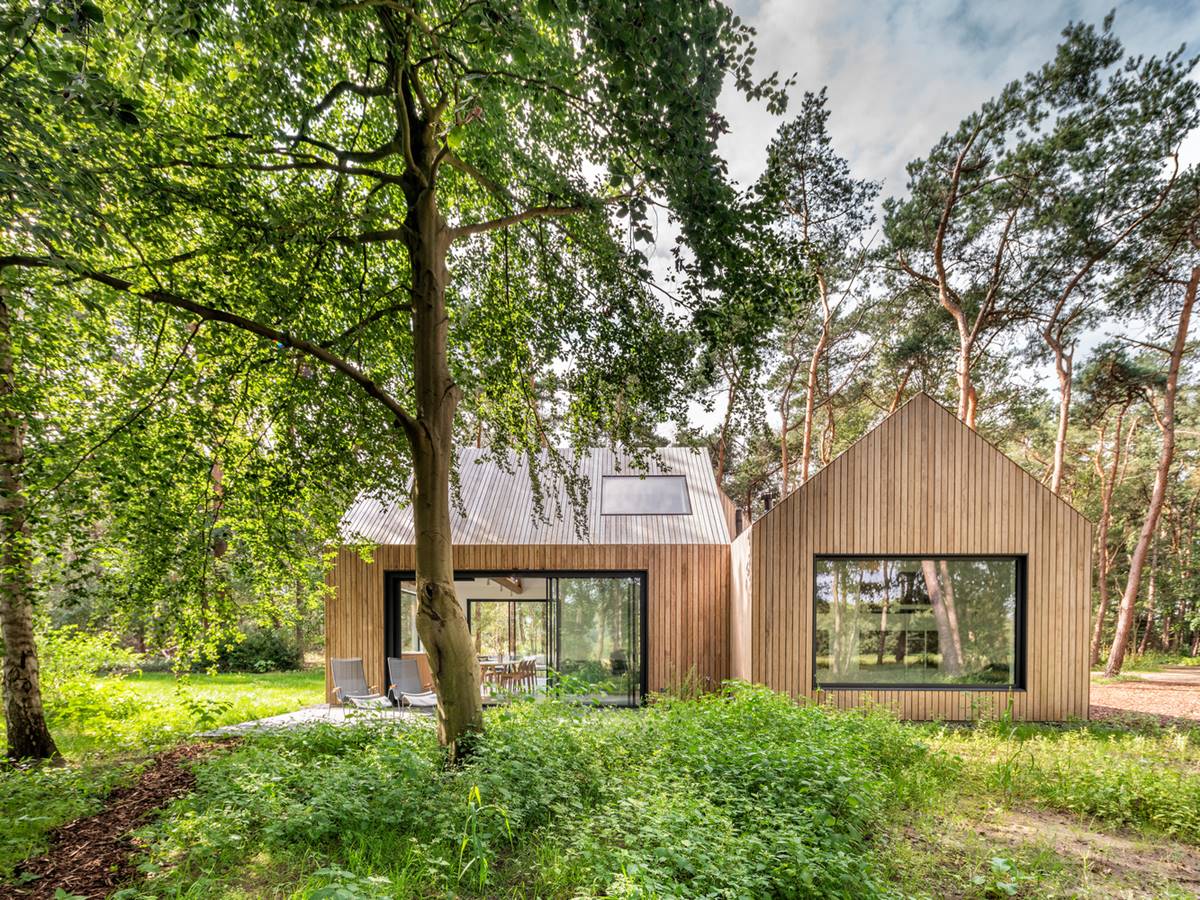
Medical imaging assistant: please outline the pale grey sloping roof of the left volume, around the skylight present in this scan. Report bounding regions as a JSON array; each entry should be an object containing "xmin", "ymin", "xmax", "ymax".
[{"xmin": 342, "ymin": 446, "xmax": 730, "ymax": 545}]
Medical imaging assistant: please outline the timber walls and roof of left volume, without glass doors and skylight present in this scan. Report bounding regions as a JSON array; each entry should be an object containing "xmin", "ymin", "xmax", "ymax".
[{"xmin": 325, "ymin": 448, "xmax": 732, "ymax": 694}]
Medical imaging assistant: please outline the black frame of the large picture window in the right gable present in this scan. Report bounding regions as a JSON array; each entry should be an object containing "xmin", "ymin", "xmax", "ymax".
[{"xmin": 809, "ymin": 553, "xmax": 1028, "ymax": 694}]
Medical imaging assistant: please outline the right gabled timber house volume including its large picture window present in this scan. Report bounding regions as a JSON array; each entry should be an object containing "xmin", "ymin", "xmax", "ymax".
[{"xmin": 730, "ymin": 394, "xmax": 1092, "ymax": 720}]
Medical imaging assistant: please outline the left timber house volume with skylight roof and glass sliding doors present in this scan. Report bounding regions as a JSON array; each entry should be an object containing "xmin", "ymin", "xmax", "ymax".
[{"xmin": 325, "ymin": 448, "xmax": 732, "ymax": 704}]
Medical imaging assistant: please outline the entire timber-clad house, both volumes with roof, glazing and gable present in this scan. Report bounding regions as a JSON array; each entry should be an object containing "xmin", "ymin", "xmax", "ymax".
[{"xmin": 325, "ymin": 395, "xmax": 1092, "ymax": 720}]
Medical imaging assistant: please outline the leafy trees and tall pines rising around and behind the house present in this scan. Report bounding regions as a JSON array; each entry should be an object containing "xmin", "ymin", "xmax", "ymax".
[{"xmin": 0, "ymin": 4, "xmax": 1200, "ymax": 753}]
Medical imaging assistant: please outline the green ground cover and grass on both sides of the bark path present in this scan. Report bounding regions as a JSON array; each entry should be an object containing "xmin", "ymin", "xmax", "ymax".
[{"xmin": 0, "ymin": 672, "xmax": 1200, "ymax": 898}]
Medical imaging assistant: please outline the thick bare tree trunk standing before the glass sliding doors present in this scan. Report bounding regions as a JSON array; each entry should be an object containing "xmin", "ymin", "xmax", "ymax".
[{"xmin": 406, "ymin": 154, "xmax": 484, "ymax": 763}]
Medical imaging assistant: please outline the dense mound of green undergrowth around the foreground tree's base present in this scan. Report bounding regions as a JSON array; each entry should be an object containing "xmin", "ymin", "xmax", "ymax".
[{"xmin": 131, "ymin": 685, "xmax": 936, "ymax": 898}]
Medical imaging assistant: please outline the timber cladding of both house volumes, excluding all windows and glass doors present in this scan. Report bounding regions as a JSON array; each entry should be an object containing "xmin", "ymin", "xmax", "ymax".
[{"xmin": 325, "ymin": 395, "xmax": 1092, "ymax": 720}]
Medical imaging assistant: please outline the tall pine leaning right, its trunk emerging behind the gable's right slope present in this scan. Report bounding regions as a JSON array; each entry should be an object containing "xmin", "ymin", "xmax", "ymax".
[{"xmin": 1027, "ymin": 19, "xmax": 1200, "ymax": 493}]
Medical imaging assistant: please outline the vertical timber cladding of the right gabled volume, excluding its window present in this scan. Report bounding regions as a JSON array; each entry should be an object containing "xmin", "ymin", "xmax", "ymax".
[{"xmin": 731, "ymin": 395, "xmax": 1092, "ymax": 720}]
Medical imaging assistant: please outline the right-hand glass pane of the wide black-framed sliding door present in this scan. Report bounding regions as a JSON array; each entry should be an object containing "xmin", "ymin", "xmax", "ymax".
[{"xmin": 558, "ymin": 577, "xmax": 642, "ymax": 703}]
